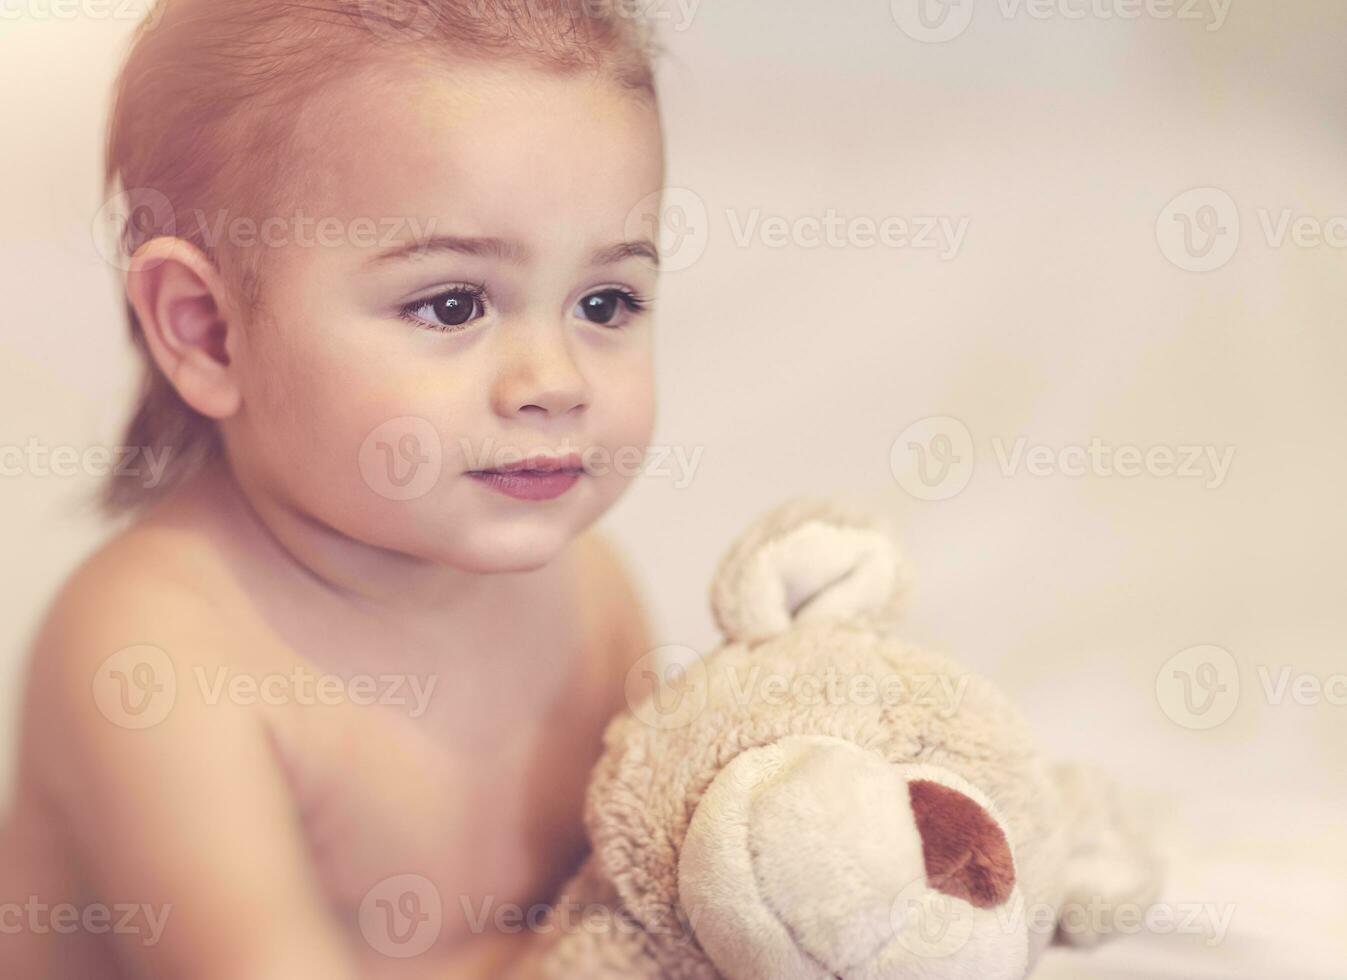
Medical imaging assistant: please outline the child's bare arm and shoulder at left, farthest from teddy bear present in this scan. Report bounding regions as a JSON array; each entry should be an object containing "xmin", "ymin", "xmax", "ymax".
[{"xmin": 24, "ymin": 571, "xmax": 357, "ymax": 980}]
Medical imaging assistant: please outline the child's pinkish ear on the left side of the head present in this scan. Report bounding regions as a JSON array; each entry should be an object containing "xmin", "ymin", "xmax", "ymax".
[{"xmin": 127, "ymin": 238, "xmax": 240, "ymax": 419}]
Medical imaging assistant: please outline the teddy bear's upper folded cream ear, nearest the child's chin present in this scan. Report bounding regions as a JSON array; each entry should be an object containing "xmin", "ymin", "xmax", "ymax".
[{"xmin": 711, "ymin": 498, "xmax": 908, "ymax": 643}]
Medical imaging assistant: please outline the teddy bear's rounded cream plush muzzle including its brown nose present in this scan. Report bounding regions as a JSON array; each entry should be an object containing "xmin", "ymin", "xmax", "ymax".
[{"xmin": 679, "ymin": 735, "xmax": 1029, "ymax": 980}]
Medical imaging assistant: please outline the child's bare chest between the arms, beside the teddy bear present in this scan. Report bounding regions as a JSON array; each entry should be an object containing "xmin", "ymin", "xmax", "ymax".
[{"xmin": 246, "ymin": 589, "xmax": 614, "ymax": 960}]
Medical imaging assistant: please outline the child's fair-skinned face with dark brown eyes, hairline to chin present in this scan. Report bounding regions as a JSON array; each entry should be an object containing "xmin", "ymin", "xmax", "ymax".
[{"xmin": 226, "ymin": 57, "xmax": 663, "ymax": 571}]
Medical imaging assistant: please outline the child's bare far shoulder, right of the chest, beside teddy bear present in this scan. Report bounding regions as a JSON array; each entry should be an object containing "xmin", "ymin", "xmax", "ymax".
[{"xmin": 577, "ymin": 529, "xmax": 653, "ymax": 709}]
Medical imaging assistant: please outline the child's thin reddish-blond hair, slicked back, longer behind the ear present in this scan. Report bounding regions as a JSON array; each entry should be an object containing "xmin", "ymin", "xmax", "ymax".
[{"xmin": 101, "ymin": 0, "xmax": 656, "ymax": 516}]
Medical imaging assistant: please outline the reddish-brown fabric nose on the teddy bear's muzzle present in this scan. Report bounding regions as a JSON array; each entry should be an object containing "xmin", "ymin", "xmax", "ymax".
[{"xmin": 908, "ymin": 779, "xmax": 1014, "ymax": 909}]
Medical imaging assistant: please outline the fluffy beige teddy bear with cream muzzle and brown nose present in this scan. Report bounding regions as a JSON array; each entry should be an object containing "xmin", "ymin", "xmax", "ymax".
[{"xmin": 521, "ymin": 499, "xmax": 1157, "ymax": 980}]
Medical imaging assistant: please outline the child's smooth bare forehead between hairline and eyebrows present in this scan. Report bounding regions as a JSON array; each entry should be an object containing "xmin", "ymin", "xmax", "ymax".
[{"xmin": 278, "ymin": 62, "xmax": 663, "ymax": 231}]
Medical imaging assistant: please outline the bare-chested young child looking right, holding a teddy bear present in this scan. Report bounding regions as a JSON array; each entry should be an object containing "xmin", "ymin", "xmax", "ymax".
[{"xmin": 0, "ymin": 0, "xmax": 663, "ymax": 980}]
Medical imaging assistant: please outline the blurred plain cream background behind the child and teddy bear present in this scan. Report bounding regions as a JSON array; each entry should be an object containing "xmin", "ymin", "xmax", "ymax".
[{"xmin": 0, "ymin": 0, "xmax": 1347, "ymax": 979}]
